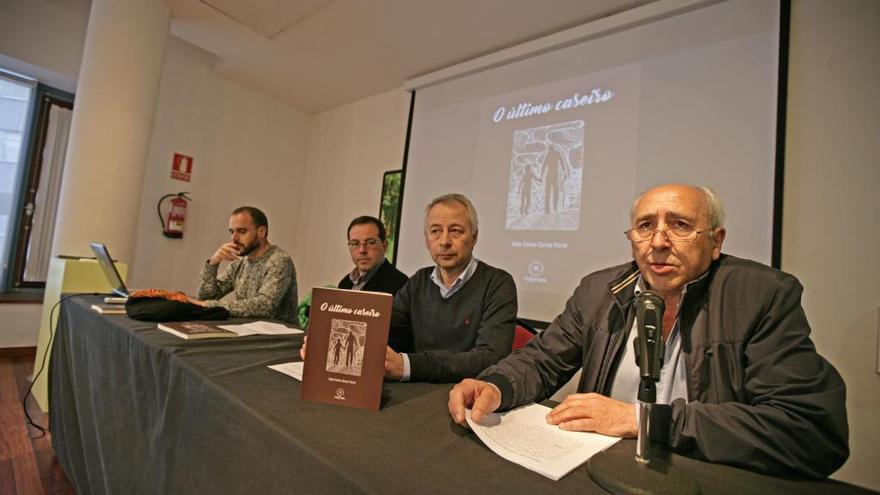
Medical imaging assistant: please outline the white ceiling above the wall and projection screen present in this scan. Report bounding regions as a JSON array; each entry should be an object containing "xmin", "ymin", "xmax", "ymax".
[{"xmin": 168, "ymin": 0, "xmax": 650, "ymax": 113}]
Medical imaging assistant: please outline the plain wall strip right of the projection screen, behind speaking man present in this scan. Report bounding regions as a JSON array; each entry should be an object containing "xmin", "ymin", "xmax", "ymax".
[{"xmin": 782, "ymin": 0, "xmax": 880, "ymax": 490}]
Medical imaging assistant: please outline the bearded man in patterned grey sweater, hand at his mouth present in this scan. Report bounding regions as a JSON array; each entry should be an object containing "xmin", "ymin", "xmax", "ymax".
[{"xmin": 193, "ymin": 206, "xmax": 297, "ymax": 323}]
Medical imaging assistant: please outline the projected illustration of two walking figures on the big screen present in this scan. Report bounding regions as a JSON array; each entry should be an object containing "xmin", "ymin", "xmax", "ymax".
[{"xmin": 507, "ymin": 120, "xmax": 584, "ymax": 230}]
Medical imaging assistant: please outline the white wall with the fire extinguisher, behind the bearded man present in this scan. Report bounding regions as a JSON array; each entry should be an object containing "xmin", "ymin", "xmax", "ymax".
[{"xmin": 128, "ymin": 37, "xmax": 309, "ymax": 294}]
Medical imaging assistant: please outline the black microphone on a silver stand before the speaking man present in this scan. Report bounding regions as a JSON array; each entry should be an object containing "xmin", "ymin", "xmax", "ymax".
[{"xmin": 633, "ymin": 291, "xmax": 666, "ymax": 463}]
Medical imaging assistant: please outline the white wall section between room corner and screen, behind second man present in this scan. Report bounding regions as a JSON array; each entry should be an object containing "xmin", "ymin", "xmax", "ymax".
[{"xmin": 295, "ymin": 89, "xmax": 410, "ymax": 297}]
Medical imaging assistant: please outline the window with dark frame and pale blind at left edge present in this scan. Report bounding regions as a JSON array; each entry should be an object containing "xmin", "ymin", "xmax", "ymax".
[{"xmin": 0, "ymin": 71, "xmax": 73, "ymax": 292}]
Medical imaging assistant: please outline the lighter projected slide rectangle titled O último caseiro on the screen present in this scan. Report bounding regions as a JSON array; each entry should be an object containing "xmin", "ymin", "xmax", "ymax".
[{"xmin": 471, "ymin": 64, "xmax": 641, "ymax": 292}]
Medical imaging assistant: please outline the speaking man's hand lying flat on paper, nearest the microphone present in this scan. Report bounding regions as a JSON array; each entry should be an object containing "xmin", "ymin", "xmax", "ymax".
[{"xmin": 547, "ymin": 393, "xmax": 638, "ymax": 437}]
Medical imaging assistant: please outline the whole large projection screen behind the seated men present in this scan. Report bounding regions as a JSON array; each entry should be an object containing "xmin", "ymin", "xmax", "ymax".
[{"xmin": 398, "ymin": 0, "xmax": 779, "ymax": 321}]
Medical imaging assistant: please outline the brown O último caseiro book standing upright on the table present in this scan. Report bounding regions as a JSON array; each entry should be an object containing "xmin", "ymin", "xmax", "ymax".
[{"xmin": 301, "ymin": 287, "xmax": 393, "ymax": 410}]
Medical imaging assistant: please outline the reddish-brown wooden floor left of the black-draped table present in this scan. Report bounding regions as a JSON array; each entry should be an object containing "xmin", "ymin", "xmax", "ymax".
[{"xmin": 0, "ymin": 349, "xmax": 76, "ymax": 495}]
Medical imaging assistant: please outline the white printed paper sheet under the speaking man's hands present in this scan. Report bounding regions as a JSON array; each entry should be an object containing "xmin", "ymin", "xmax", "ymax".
[{"xmin": 466, "ymin": 404, "xmax": 620, "ymax": 480}]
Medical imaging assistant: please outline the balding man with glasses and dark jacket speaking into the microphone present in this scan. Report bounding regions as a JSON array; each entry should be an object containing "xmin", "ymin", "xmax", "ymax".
[{"xmin": 449, "ymin": 184, "xmax": 849, "ymax": 477}]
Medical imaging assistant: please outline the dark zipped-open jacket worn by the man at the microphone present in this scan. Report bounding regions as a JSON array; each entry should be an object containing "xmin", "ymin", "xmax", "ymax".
[{"xmin": 481, "ymin": 255, "xmax": 849, "ymax": 477}]
